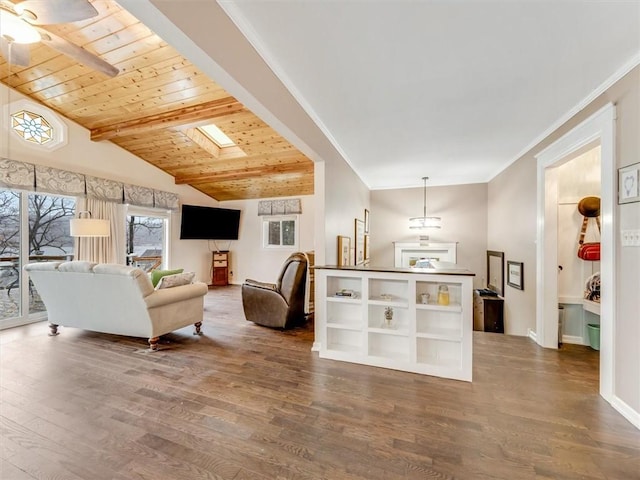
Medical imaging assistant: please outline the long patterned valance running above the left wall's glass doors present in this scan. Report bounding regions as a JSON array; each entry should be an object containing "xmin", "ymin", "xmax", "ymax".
[{"xmin": 0, "ymin": 158, "xmax": 179, "ymax": 210}]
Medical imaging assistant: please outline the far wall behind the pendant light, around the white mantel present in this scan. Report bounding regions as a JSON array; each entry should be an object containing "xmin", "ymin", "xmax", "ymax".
[{"xmin": 370, "ymin": 183, "xmax": 487, "ymax": 288}]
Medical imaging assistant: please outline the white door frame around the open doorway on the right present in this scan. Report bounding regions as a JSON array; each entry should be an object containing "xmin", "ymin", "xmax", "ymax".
[{"xmin": 535, "ymin": 103, "xmax": 617, "ymax": 403}]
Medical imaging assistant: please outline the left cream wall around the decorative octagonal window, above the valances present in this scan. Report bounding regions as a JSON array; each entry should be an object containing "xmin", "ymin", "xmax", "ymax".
[{"xmin": 0, "ymin": 85, "xmax": 217, "ymax": 283}]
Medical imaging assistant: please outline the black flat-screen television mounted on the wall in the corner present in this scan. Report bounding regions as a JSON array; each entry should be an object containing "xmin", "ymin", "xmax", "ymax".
[{"xmin": 180, "ymin": 205, "xmax": 240, "ymax": 240}]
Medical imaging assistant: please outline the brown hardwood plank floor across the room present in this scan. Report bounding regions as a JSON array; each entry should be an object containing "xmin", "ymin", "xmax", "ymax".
[{"xmin": 0, "ymin": 286, "xmax": 640, "ymax": 480}]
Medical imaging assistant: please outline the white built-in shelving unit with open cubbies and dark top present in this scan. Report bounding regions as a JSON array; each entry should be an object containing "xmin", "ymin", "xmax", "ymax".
[{"xmin": 314, "ymin": 267, "xmax": 473, "ymax": 381}]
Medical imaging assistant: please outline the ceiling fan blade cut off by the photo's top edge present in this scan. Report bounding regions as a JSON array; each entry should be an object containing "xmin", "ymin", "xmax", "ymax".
[{"xmin": 13, "ymin": 0, "xmax": 98, "ymax": 25}]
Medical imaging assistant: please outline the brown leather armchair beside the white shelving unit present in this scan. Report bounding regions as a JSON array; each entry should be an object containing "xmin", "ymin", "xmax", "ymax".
[{"xmin": 242, "ymin": 252, "xmax": 307, "ymax": 329}]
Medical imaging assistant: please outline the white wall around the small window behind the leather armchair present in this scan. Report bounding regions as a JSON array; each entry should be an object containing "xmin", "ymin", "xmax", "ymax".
[{"xmin": 218, "ymin": 195, "xmax": 315, "ymax": 285}]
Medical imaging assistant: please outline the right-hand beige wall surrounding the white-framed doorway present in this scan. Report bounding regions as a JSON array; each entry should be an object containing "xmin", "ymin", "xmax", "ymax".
[{"xmin": 488, "ymin": 67, "xmax": 640, "ymax": 419}]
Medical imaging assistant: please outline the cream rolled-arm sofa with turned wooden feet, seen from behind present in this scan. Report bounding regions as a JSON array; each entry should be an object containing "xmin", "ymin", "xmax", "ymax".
[{"xmin": 24, "ymin": 261, "xmax": 208, "ymax": 350}]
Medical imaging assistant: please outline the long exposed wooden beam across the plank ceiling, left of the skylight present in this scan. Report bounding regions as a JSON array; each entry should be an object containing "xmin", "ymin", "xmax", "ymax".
[{"xmin": 91, "ymin": 97, "xmax": 245, "ymax": 142}]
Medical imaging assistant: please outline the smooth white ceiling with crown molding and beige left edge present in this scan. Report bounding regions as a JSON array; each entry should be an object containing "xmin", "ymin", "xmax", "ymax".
[{"xmin": 119, "ymin": 0, "xmax": 640, "ymax": 189}]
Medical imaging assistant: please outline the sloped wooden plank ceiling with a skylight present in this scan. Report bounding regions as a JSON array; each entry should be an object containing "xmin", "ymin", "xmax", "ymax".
[{"xmin": 0, "ymin": 0, "xmax": 313, "ymax": 201}]
